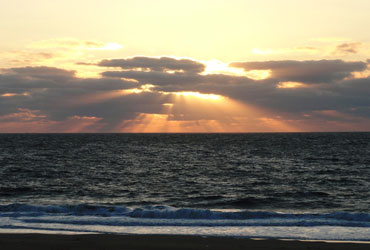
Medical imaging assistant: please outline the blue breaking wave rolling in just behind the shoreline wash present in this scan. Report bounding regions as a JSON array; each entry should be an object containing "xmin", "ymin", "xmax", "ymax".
[{"xmin": 0, "ymin": 203, "xmax": 370, "ymax": 227}]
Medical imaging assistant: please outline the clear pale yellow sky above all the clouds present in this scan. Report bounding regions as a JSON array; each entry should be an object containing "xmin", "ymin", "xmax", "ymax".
[{"xmin": 0, "ymin": 0, "xmax": 370, "ymax": 62}]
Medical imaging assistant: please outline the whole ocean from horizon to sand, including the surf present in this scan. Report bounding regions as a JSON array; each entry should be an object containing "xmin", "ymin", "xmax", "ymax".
[{"xmin": 0, "ymin": 133, "xmax": 370, "ymax": 241}]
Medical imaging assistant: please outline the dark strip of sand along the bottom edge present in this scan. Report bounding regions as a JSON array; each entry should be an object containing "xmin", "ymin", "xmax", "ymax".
[{"xmin": 0, "ymin": 234, "xmax": 370, "ymax": 250}]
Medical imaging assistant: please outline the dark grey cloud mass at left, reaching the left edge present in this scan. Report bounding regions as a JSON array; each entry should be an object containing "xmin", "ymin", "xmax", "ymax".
[{"xmin": 0, "ymin": 67, "xmax": 146, "ymax": 120}]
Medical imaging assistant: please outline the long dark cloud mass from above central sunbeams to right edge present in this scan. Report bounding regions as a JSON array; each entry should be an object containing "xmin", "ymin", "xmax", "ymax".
[{"xmin": 99, "ymin": 57, "xmax": 370, "ymax": 121}]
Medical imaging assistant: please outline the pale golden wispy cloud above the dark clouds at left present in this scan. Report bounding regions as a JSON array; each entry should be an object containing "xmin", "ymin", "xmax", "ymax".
[{"xmin": 0, "ymin": 38, "xmax": 123, "ymax": 77}]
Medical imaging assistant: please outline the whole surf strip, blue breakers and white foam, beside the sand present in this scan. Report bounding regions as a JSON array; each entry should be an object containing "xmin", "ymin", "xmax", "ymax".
[{"xmin": 0, "ymin": 205, "xmax": 370, "ymax": 241}]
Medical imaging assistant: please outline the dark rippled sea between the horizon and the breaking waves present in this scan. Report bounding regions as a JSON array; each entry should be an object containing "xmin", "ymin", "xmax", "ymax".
[{"xmin": 0, "ymin": 133, "xmax": 370, "ymax": 213}]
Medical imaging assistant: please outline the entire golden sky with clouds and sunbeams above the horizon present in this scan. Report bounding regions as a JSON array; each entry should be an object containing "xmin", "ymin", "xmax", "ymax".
[{"xmin": 0, "ymin": 0, "xmax": 370, "ymax": 133}]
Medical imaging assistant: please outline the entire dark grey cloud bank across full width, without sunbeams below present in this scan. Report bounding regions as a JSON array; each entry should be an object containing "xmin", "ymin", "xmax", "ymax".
[{"xmin": 0, "ymin": 57, "xmax": 370, "ymax": 131}]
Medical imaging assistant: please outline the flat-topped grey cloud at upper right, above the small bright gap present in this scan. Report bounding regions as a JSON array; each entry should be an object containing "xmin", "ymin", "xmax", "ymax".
[{"xmin": 230, "ymin": 60, "xmax": 367, "ymax": 83}]
